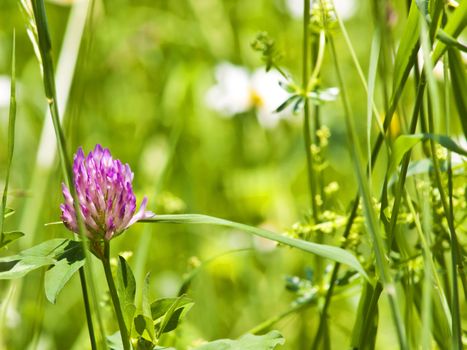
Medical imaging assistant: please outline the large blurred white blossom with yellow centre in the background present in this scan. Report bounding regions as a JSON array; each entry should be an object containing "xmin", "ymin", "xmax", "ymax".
[{"xmin": 206, "ymin": 62, "xmax": 290, "ymax": 128}]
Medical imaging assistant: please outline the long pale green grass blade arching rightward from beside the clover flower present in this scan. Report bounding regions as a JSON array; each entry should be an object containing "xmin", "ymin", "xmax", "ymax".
[{"xmin": 139, "ymin": 214, "xmax": 368, "ymax": 279}]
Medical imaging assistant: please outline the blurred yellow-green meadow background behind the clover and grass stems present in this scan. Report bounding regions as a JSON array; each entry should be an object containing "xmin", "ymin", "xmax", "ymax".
[{"xmin": 0, "ymin": 0, "xmax": 458, "ymax": 349}]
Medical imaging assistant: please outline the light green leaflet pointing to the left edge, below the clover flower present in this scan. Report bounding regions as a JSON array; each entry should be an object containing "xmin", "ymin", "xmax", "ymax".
[{"xmin": 0, "ymin": 238, "xmax": 77, "ymax": 279}]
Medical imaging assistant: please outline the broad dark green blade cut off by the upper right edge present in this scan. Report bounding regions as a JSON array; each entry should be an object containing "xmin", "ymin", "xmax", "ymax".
[{"xmin": 448, "ymin": 49, "xmax": 467, "ymax": 137}]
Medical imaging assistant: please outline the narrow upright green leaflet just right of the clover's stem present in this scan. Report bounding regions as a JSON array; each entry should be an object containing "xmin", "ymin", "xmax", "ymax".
[{"xmin": 116, "ymin": 256, "xmax": 136, "ymax": 331}]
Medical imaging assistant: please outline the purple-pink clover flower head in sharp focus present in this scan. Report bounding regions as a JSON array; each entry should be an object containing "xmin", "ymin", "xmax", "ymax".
[{"xmin": 60, "ymin": 144, "xmax": 154, "ymax": 241}]
